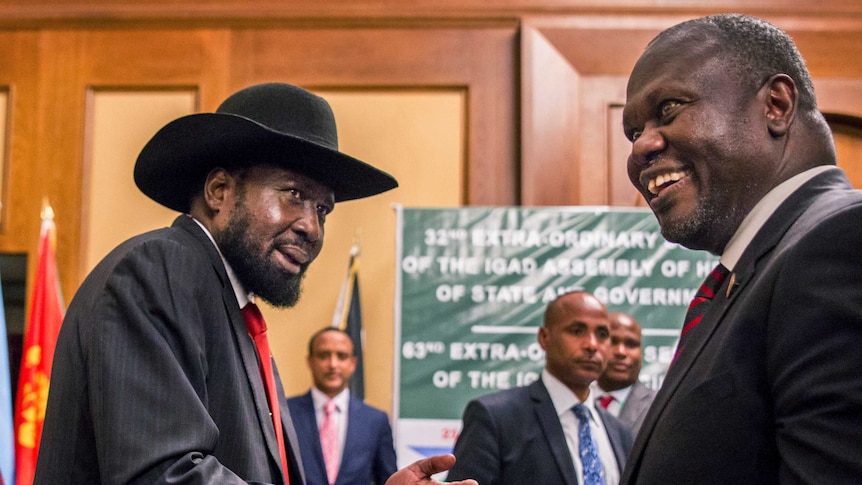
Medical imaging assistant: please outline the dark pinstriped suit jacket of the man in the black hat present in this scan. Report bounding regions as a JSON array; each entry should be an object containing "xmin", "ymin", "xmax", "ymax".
[{"xmin": 35, "ymin": 215, "xmax": 304, "ymax": 485}]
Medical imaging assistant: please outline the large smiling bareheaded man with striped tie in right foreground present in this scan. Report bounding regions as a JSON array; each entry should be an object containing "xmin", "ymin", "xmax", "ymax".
[{"xmin": 622, "ymin": 15, "xmax": 862, "ymax": 485}]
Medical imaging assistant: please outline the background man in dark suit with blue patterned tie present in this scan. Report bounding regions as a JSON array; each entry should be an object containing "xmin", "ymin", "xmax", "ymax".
[{"xmin": 449, "ymin": 291, "xmax": 631, "ymax": 485}]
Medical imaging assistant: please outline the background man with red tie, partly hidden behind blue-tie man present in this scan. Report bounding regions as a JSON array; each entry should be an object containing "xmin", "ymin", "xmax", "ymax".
[{"xmin": 596, "ymin": 312, "xmax": 655, "ymax": 436}]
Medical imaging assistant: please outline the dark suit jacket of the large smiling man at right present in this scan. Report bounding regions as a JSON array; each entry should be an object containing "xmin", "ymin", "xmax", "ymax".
[{"xmin": 621, "ymin": 170, "xmax": 862, "ymax": 485}]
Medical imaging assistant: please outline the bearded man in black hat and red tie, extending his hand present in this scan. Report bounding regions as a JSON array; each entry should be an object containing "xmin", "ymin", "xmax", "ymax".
[{"xmin": 35, "ymin": 83, "xmax": 476, "ymax": 485}]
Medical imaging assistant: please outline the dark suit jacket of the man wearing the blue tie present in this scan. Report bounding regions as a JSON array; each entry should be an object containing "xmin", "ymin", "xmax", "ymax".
[{"xmin": 448, "ymin": 379, "xmax": 631, "ymax": 485}]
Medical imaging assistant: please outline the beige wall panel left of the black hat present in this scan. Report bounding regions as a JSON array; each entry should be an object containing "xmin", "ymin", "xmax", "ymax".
[{"xmin": 83, "ymin": 91, "xmax": 197, "ymax": 272}]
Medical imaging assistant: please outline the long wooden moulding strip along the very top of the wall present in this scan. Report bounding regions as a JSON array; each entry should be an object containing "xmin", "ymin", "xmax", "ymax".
[{"xmin": 0, "ymin": 0, "xmax": 862, "ymax": 28}]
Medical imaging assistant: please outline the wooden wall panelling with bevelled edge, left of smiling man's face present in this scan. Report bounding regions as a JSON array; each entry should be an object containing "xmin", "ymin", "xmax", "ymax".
[{"xmin": 521, "ymin": 17, "xmax": 668, "ymax": 206}]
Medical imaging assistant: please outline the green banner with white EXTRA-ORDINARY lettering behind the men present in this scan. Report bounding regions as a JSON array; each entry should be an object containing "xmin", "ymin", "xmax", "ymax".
[{"xmin": 394, "ymin": 207, "xmax": 718, "ymax": 463}]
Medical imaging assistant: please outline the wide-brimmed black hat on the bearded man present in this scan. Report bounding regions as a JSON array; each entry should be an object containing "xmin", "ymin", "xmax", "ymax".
[{"xmin": 135, "ymin": 83, "xmax": 398, "ymax": 212}]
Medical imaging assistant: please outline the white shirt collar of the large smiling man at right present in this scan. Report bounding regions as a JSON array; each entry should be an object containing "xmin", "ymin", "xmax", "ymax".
[{"xmin": 720, "ymin": 165, "xmax": 838, "ymax": 271}]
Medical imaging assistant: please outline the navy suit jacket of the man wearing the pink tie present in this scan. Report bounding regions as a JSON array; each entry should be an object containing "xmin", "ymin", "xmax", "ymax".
[{"xmin": 287, "ymin": 391, "xmax": 398, "ymax": 485}]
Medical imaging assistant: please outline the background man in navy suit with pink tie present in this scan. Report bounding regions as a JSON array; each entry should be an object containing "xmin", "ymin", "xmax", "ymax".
[{"xmin": 287, "ymin": 327, "xmax": 397, "ymax": 485}]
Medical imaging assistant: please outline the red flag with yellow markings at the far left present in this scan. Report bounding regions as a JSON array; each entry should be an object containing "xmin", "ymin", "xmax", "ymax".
[{"xmin": 15, "ymin": 206, "xmax": 65, "ymax": 485}]
